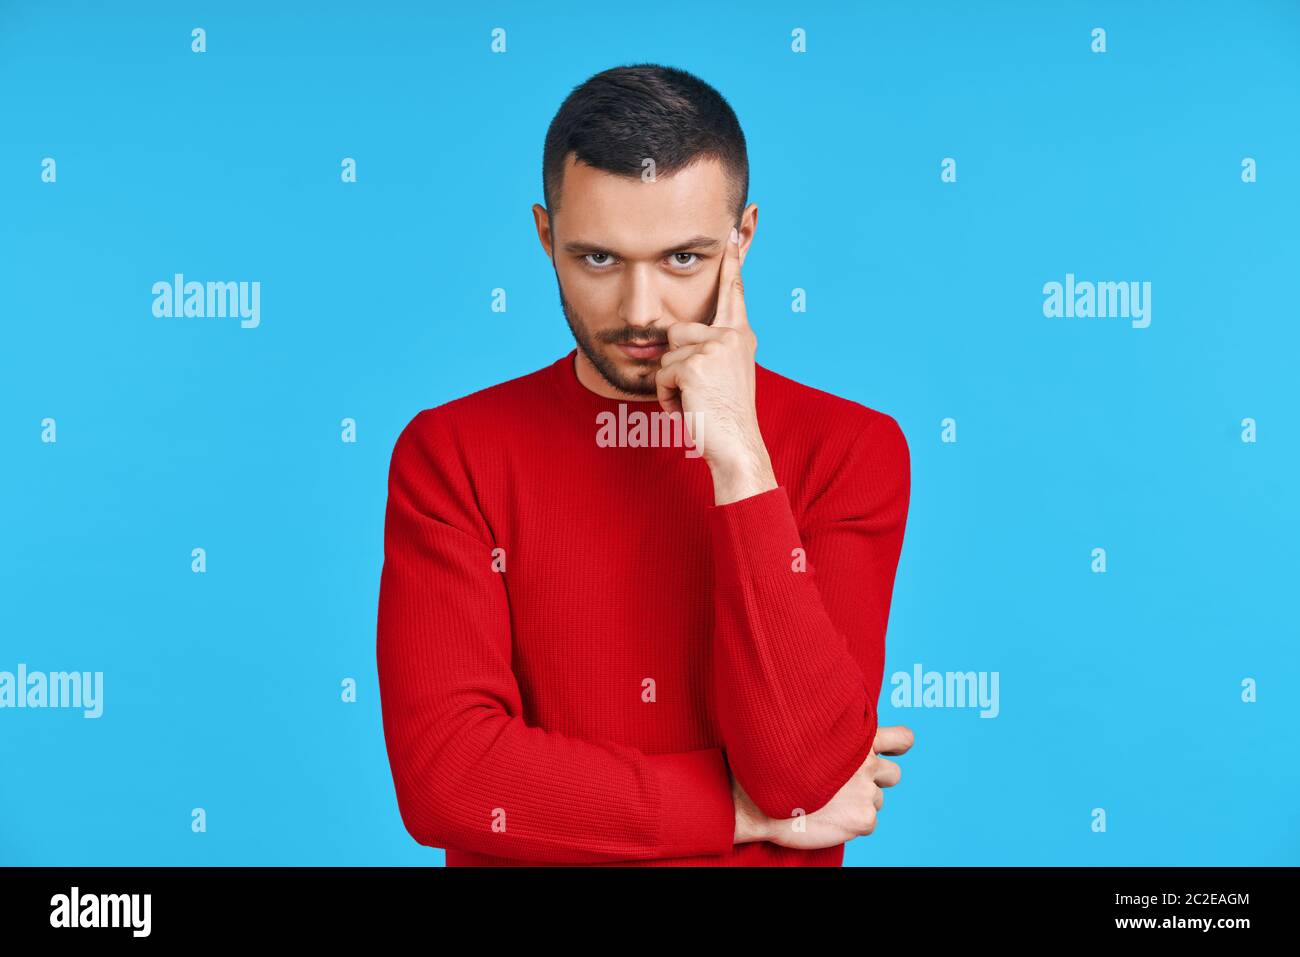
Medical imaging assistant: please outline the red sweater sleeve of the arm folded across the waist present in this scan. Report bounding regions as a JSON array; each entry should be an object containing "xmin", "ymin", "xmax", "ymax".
[{"xmin": 376, "ymin": 410, "xmax": 736, "ymax": 865}]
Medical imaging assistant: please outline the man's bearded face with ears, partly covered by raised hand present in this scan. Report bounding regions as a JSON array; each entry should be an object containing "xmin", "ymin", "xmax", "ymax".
[{"xmin": 533, "ymin": 153, "xmax": 758, "ymax": 399}]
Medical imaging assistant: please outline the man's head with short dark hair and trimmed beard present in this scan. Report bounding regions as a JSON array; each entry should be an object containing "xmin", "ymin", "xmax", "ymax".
[{"xmin": 533, "ymin": 64, "xmax": 758, "ymax": 398}]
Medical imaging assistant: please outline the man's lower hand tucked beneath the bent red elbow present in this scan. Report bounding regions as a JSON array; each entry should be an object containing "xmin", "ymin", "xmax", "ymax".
[{"xmin": 732, "ymin": 724, "xmax": 915, "ymax": 850}]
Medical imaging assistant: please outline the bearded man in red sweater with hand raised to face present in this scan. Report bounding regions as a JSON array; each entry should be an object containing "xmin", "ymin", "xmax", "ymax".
[{"xmin": 377, "ymin": 65, "xmax": 911, "ymax": 866}]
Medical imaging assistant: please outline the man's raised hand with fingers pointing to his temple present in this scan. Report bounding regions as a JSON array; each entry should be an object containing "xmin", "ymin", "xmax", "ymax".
[{"xmin": 655, "ymin": 229, "xmax": 777, "ymax": 505}]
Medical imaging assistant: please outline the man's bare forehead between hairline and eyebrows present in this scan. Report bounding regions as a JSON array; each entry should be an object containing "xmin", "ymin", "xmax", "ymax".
[{"xmin": 555, "ymin": 153, "xmax": 731, "ymax": 255}]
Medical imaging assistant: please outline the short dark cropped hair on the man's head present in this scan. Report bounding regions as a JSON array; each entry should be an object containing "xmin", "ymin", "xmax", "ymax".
[{"xmin": 542, "ymin": 64, "xmax": 749, "ymax": 225}]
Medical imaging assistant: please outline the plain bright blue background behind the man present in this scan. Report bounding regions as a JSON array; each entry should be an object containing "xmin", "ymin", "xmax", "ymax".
[{"xmin": 0, "ymin": 3, "xmax": 1300, "ymax": 865}]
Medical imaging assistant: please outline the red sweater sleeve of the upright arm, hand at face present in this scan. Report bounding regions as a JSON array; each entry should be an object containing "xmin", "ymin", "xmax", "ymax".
[{"xmin": 710, "ymin": 412, "xmax": 911, "ymax": 819}]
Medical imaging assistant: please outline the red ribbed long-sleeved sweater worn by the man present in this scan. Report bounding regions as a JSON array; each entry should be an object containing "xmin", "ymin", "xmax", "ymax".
[{"xmin": 377, "ymin": 350, "xmax": 911, "ymax": 866}]
